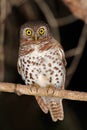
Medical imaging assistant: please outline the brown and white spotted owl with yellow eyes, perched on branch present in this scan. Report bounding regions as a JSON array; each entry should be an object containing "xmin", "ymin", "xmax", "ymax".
[{"xmin": 18, "ymin": 22, "xmax": 66, "ymax": 121}]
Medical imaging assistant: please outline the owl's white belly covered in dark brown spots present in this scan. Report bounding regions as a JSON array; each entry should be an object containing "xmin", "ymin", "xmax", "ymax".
[{"xmin": 20, "ymin": 50, "xmax": 65, "ymax": 87}]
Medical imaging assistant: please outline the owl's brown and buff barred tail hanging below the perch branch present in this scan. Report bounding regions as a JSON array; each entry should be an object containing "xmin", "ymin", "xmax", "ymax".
[{"xmin": 49, "ymin": 99, "xmax": 64, "ymax": 122}]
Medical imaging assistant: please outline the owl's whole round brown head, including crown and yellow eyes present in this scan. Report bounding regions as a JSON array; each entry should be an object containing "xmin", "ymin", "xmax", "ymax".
[{"xmin": 20, "ymin": 22, "xmax": 51, "ymax": 43}]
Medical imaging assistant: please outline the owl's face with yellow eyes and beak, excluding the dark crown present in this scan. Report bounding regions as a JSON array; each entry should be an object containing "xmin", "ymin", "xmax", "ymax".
[{"xmin": 21, "ymin": 26, "xmax": 48, "ymax": 44}]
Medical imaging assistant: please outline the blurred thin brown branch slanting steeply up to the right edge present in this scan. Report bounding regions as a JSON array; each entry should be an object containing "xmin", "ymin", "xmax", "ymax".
[{"xmin": 66, "ymin": 24, "xmax": 87, "ymax": 86}]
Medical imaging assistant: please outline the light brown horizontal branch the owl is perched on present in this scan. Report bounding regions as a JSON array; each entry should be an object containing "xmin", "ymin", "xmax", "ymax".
[{"xmin": 0, "ymin": 83, "xmax": 87, "ymax": 101}]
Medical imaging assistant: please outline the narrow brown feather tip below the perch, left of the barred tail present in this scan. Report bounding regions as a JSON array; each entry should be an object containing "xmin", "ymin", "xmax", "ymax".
[{"xmin": 35, "ymin": 96, "xmax": 48, "ymax": 113}]
